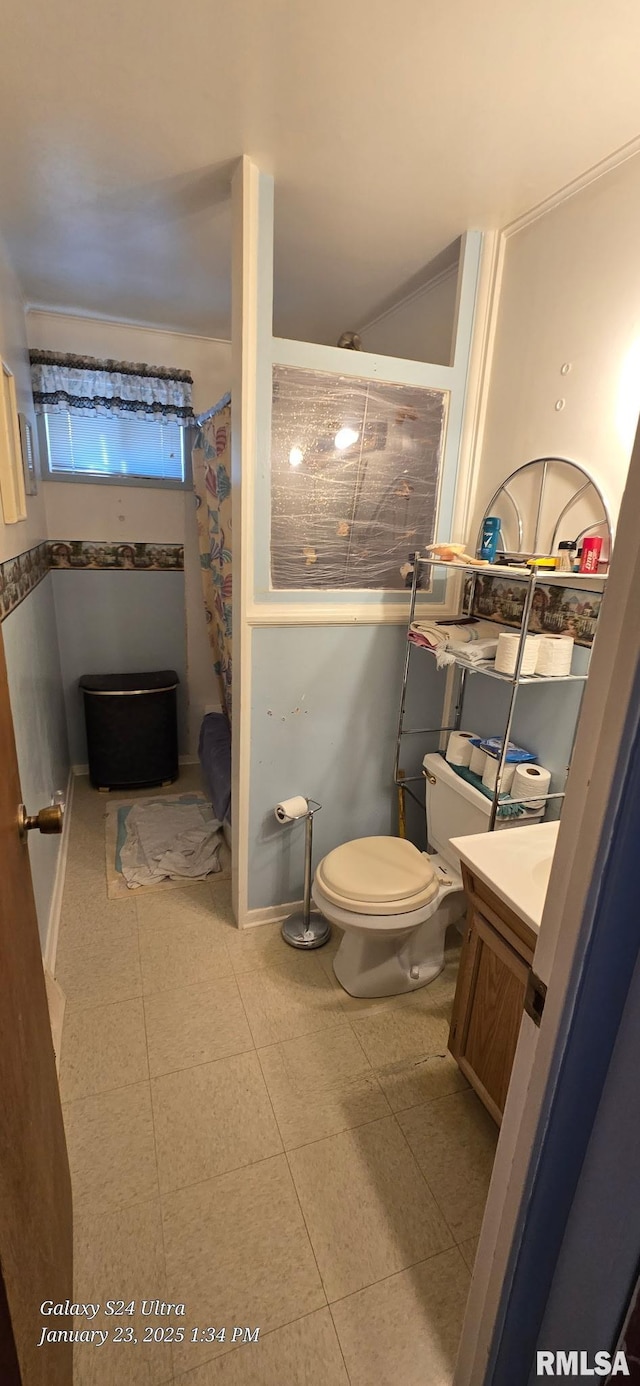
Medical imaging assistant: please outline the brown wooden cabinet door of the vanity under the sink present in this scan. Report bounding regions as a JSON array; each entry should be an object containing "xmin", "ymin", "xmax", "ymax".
[{"xmin": 449, "ymin": 909, "xmax": 529, "ymax": 1124}]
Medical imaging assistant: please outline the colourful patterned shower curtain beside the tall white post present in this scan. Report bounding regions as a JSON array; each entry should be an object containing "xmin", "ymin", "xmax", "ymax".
[{"xmin": 191, "ymin": 395, "xmax": 231, "ymax": 721}]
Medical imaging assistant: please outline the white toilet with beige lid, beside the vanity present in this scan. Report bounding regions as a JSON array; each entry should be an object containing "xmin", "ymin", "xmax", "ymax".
[{"xmin": 312, "ymin": 754, "xmax": 544, "ymax": 997}]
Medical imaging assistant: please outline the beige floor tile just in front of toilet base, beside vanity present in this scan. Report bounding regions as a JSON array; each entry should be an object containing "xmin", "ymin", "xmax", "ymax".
[{"xmin": 349, "ymin": 992, "xmax": 449, "ymax": 1069}]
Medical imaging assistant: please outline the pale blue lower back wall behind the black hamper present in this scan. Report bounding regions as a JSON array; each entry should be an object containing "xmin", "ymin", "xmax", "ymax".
[{"xmin": 51, "ymin": 568, "xmax": 187, "ymax": 765}]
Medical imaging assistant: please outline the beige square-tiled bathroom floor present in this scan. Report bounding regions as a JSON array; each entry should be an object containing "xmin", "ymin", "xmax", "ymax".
[{"xmin": 57, "ymin": 769, "xmax": 496, "ymax": 1386}]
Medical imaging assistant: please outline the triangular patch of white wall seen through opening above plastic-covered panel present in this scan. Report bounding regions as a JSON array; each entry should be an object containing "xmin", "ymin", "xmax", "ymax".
[{"xmin": 360, "ymin": 263, "xmax": 459, "ymax": 366}]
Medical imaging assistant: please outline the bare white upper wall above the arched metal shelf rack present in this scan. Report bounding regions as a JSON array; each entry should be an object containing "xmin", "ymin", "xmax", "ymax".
[{"xmin": 470, "ymin": 157, "xmax": 640, "ymax": 535}]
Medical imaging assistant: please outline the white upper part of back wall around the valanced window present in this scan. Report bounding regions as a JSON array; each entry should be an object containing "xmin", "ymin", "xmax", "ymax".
[{"xmin": 26, "ymin": 310, "xmax": 231, "ymax": 755}]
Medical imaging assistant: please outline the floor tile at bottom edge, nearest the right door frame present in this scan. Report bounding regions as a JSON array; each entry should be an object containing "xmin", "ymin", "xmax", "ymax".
[{"xmin": 331, "ymin": 1249, "xmax": 470, "ymax": 1386}]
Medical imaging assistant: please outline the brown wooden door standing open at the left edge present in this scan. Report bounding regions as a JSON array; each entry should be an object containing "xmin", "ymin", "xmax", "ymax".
[{"xmin": 0, "ymin": 629, "xmax": 73, "ymax": 1386}]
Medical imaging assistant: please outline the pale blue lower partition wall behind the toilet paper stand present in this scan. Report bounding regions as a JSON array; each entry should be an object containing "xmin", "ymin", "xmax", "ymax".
[{"xmin": 249, "ymin": 625, "xmax": 445, "ymax": 909}]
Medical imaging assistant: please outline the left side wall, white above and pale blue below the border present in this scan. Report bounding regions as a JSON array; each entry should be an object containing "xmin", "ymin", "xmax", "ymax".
[{"xmin": 0, "ymin": 244, "xmax": 68, "ymax": 948}]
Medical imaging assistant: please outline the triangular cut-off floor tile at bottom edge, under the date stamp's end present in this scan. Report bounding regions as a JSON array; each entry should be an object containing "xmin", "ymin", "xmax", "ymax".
[{"xmin": 176, "ymin": 1308, "xmax": 349, "ymax": 1386}]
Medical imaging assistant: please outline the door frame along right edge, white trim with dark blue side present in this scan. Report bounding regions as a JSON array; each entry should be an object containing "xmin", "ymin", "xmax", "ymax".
[{"xmin": 454, "ymin": 415, "xmax": 640, "ymax": 1386}]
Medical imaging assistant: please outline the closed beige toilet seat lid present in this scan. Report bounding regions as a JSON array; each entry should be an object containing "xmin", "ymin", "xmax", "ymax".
[{"xmin": 316, "ymin": 837, "xmax": 439, "ymax": 916}]
